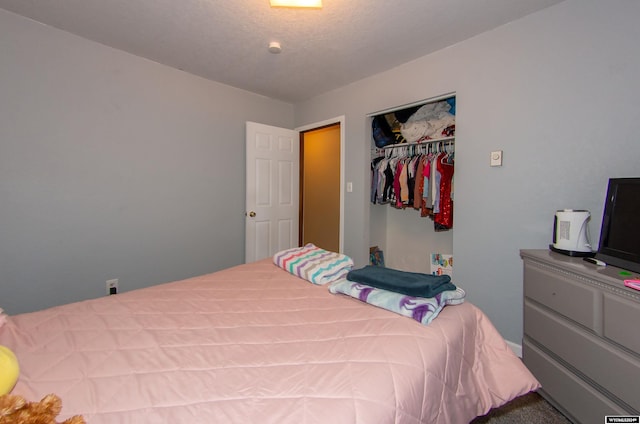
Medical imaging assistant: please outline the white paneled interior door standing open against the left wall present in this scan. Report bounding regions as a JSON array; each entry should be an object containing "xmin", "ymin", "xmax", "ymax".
[{"xmin": 245, "ymin": 122, "xmax": 300, "ymax": 262}]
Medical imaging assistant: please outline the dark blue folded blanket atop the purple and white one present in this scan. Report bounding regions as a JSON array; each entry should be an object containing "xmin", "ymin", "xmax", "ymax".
[{"xmin": 347, "ymin": 265, "xmax": 456, "ymax": 297}]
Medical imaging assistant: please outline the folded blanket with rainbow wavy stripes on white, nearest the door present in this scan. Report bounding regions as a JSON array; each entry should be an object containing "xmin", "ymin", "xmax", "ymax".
[{"xmin": 273, "ymin": 243, "xmax": 353, "ymax": 284}]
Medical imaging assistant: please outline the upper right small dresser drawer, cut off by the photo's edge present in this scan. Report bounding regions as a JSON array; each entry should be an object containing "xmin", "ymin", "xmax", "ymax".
[{"xmin": 603, "ymin": 293, "xmax": 640, "ymax": 352}]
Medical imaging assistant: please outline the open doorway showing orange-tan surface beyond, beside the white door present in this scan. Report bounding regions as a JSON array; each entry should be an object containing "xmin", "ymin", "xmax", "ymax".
[{"xmin": 298, "ymin": 122, "xmax": 342, "ymax": 252}]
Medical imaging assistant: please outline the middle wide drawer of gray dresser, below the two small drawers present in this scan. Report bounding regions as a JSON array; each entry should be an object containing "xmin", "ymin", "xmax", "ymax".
[{"xmin": 524, "ymin": 301, "xmax": 640, "ymax": 411}]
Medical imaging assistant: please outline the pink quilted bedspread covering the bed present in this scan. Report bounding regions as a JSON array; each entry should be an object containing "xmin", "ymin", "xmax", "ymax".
[{"xmin": 0, "ymin": 260, "xmax": 538, "ymax": 424}]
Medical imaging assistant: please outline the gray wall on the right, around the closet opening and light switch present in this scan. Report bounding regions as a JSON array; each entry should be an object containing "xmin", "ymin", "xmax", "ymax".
[{"xmin": 295, "ymin": 0, "xmax": 640, "ymax": 344}]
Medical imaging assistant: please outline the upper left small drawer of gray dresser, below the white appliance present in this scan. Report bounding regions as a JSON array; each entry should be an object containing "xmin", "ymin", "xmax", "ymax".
[{"xmin": 524, "ymin": 263, "xmax": 602, "ymax": 333}]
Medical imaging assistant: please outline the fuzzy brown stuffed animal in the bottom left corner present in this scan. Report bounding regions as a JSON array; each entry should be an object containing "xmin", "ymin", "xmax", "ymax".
[{"xmin": 0, "ymin": 394, "xmax": 86, "ymax": 424}]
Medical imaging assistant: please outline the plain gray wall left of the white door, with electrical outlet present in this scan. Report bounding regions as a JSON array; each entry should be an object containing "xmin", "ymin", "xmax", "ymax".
[{"xmin": 0, "ymin": 10, "xmax": 294, "ymax": 314}]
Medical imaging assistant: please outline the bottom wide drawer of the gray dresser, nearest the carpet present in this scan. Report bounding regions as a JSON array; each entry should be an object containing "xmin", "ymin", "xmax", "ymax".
[{"xmin": 522, "ymin": 339, "xmax": 628, "ymax": 423}]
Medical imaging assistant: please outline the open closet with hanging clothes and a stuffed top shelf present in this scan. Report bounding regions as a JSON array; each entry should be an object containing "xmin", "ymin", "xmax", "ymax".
[{"xmin": 368, "ymin": 93, "xmax": 456, "ymax": 274}]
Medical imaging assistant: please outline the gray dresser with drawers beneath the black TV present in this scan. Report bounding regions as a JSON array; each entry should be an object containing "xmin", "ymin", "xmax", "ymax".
[{"xmin": 520, "ymin": 250, "xmax": 640, "ymax": 423}]
